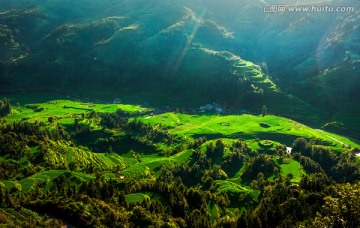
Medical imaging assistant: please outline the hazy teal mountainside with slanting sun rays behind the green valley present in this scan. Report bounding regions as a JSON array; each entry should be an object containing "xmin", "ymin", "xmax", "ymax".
[{"xmin": 0, "ymin": 0, "xmax": 360, "ymax": 135}]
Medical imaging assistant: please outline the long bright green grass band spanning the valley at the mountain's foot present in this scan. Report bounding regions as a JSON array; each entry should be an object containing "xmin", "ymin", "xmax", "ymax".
[{"xmin": 2, "ymin": 94, "xmax": 359, "ymax": 151}]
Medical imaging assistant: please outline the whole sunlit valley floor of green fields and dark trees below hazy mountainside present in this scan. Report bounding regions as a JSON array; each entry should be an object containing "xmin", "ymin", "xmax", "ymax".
[{"xmin": 0, "ymin": 93, "xmax": 359, "ymax": 226}]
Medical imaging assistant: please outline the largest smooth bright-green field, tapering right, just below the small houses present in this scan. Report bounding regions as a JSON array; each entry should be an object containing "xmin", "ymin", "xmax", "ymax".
[{"xmin": 141, "ymin": 113, "xmax": 359, "ymax": 148}]
